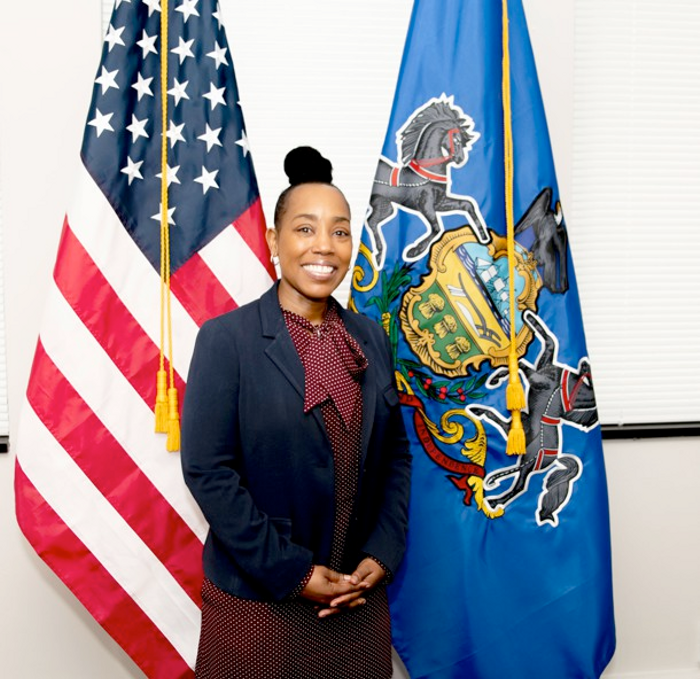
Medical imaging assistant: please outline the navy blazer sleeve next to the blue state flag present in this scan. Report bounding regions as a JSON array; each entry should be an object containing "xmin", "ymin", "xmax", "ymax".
[{"xmin": 362, "ymin": 330, "xmax": 412, "ymax": 576}]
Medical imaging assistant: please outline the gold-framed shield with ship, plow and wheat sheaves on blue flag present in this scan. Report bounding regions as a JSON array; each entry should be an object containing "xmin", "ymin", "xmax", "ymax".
[{"xmin": 399, "ymin": 226, "xmax": 542, "ymax": 377}]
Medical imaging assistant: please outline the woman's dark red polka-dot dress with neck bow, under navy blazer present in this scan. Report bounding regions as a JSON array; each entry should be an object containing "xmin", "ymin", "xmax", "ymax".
[{"xmin": 196, "ymin": 305, "xmax": 392, "ymax": 679}]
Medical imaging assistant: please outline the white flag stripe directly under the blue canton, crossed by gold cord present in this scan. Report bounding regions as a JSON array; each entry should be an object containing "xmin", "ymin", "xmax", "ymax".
[{"xmin": 68, "ymin": 163, "xmax": 198, "ymax": 380}]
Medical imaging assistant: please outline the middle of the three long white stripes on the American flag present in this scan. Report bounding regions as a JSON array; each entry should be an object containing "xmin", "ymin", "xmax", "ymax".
[{"xmin": 41, "ymin": 285, "xmax": 207, "ymax": 541}]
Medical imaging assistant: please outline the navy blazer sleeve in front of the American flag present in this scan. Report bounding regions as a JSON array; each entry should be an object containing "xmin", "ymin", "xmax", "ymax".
[{"xmin": 181, "ymin": 319, "xmax": 313, "ymax": 600}]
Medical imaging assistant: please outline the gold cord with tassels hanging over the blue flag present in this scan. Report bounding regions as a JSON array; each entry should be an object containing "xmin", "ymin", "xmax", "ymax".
[{"xmin": 503, "ymin": 0, "xmax": 526, "ymax": 455}]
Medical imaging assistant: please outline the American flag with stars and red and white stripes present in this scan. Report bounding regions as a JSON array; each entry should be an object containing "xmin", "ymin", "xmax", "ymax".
[{"xmin": 15, "ymin": 0, "xmax": 274, "ymax": 679}]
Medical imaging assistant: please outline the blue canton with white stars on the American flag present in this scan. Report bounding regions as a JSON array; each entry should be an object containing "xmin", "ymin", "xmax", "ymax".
[{"xmin": 81, "ymin": 0, "xmax": 258, "ymax": 272}]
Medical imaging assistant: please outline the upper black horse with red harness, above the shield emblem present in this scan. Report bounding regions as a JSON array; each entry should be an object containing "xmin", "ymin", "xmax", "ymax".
[{"xmin": 367, "ymin": 95, "xmax": 490, "ymax": 269}]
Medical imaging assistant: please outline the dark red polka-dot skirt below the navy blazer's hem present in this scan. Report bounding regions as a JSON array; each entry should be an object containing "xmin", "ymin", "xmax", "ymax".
[{"xmin": 196, "ymin": 580, "xmax": 392, "ymax": 679}]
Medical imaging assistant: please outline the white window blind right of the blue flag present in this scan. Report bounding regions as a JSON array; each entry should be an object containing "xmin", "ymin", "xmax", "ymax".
[{"xmin": 567, "ymin": 0, "xmax": 700, "ymax": 425}]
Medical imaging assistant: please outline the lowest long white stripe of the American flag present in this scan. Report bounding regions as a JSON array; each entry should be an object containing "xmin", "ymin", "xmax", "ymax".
[{"xmin": 19, "ymin": 402, "xmax": 201, "ymax": 667}]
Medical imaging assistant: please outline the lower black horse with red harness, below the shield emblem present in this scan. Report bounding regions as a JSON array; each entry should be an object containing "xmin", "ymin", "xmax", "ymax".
[{"xmin": 468, "ymin": 311, "xmax": 598, "ymax": 526}]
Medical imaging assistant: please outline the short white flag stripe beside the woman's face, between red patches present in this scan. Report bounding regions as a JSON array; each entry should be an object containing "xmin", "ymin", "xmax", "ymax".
[{"xmin": 199, "ymin": 226, "xmax": 272, "ymax": 306}]
